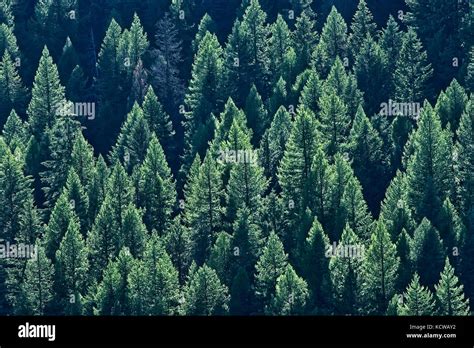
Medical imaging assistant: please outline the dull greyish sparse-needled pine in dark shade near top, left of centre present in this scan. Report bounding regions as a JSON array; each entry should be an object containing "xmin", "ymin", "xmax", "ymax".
[{"xmin": 151, "ymin": 13, "xmax": 184, "ymax": 113}]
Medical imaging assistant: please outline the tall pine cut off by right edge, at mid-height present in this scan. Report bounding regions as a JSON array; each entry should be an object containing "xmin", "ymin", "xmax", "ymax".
[{"xmin": 456, "ymin": 95, "xmax": 474, "ymax": 229}]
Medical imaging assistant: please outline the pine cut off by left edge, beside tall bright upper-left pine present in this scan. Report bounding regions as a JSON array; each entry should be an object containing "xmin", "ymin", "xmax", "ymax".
[{"xmin": 0, "ymin": 51, "xmax": 27, "ymax": 127}]
